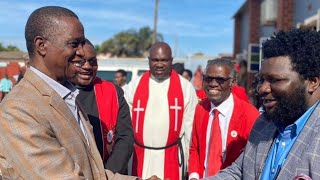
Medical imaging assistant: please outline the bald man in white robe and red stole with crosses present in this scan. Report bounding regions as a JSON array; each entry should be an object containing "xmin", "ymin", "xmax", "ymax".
[{"xmin": 125, "ymin": 42, "xmax": 197, "ymax": 180}]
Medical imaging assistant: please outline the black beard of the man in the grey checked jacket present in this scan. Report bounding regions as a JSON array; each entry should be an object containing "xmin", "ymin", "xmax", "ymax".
[{"xmin": 265, "ymin": 85, "xmax": 308, "ymax": 127}]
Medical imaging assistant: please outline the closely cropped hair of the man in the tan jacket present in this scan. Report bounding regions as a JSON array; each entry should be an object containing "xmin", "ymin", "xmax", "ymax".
[{"xmin": 25, "ymin": 6, "xmax": 79, "ymax": 57}]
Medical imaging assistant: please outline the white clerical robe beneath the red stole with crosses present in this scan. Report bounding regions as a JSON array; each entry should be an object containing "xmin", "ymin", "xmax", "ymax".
[{"xmin": 125, "ymin": 75, "xmax": 198, "ymax": 179}]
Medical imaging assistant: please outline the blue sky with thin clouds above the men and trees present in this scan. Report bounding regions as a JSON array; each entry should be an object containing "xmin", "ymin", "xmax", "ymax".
[{"xmin": 0, "ymin": 0, "xmax": 245, "ymax": 57}]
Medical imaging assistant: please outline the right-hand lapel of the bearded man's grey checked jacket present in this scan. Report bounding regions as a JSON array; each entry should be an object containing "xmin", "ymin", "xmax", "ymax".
[{"xmin": 278, "ymin": 104, "xmax": 320, "ymax": 179}]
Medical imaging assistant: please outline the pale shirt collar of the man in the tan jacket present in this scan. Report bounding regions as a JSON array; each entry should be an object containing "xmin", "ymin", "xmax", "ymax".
[{"xmin": 30, "ymin": 66, "xmax": 79, "ymax": 99}]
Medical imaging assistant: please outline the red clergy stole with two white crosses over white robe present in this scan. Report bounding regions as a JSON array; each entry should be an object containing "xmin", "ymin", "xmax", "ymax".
[{"xmin": 132, "ymin": 71, "xmax": 184, "ymax": 179}]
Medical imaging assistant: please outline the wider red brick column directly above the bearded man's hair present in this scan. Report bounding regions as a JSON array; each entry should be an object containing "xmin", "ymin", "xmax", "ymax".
[{"xmin": 277, "ymin": 0, "xmax": 294, "ymax": 31}]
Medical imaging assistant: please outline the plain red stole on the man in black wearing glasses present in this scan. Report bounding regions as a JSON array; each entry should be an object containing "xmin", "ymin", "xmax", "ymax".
[{"xmin": 93, "ymin": 77, "xmax": 119, "ymax": 160}]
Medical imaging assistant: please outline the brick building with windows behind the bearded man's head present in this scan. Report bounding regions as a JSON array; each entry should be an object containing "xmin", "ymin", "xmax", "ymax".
[{"xmin": 233, "ymin": 0, "xmax": 320, "ymax": 67}]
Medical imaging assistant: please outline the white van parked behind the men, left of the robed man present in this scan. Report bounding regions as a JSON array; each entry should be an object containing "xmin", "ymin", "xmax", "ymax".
[{"xmin": 97, "ymin": 58, "xmax": 149, "ymax": 83}]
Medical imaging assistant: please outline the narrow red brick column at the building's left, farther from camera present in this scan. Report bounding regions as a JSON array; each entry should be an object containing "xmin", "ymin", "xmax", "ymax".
[{"xmin": 248, "ymin": 0, "xmax": 260, "ymax": 43}]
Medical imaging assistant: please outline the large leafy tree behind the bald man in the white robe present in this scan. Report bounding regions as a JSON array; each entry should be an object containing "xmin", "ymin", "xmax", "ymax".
[{"xmin": 98, "ymin": 27, "xmax": 163, "ymax": 57}]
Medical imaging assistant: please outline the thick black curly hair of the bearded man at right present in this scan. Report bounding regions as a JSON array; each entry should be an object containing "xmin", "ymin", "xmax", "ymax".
[{"xmin": 262, "ymin": 29, "xmax": 320, "ymax": 79}]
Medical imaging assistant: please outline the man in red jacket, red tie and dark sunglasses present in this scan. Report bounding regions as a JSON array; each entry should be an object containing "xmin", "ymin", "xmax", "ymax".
[{"xmin": 188, "ymin": 59, "xmax": 259, "ymax": 180}]
